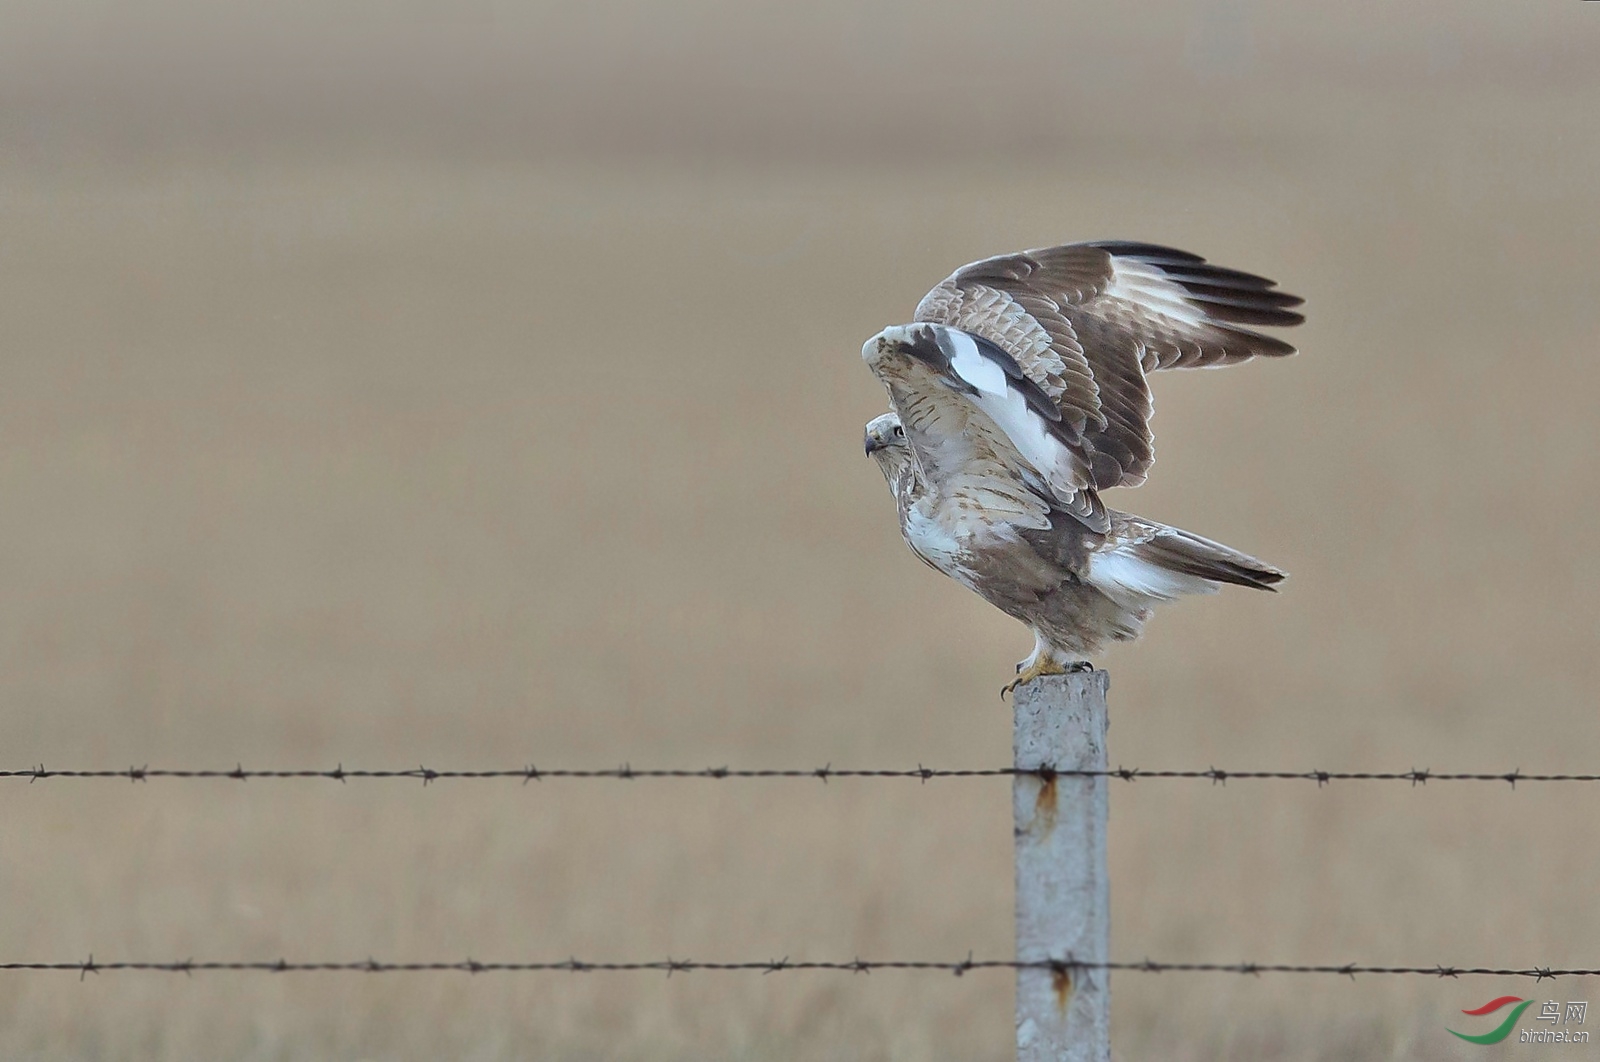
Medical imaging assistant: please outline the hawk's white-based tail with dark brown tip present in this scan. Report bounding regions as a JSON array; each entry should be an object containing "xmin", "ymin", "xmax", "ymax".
[{"xmin": 1088, "ymin": 521, "xmax": 1288, "ymax": 600}]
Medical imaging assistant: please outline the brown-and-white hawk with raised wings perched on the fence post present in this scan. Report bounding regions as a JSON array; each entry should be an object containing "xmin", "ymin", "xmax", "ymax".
[{"xmin": 861, "ymin": 242, "xmax": 1304, "ymax": 689}]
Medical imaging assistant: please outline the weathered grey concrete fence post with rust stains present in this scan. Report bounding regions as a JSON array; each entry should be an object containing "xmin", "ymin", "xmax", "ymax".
[{"xmin": 1011, "ymin": 672, "xmax": 1110, "ymax": 1062}]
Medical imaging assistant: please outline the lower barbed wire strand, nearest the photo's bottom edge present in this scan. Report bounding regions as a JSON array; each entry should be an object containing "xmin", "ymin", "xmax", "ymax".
[{"xmin": 9, "ymin": 955, "xmax": 1600, "ymax": 980}]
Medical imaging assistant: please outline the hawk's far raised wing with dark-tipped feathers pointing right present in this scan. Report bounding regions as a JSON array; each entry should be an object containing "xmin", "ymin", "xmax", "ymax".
[{"xmin": 917, "ymin": 242, "xmax": 1306, "ymax": 491}]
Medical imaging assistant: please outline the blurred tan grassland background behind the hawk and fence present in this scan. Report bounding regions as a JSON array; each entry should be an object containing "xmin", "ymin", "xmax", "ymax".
[{"xmin": 0, "ymin": 0, "xmax": 1600, "ymax": 1062}]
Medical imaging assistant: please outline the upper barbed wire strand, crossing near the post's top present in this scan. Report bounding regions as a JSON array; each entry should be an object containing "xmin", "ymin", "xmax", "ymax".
[{"xmin": 0, "ymin": 763, "xmax": 1600, "ymax": 789}]
